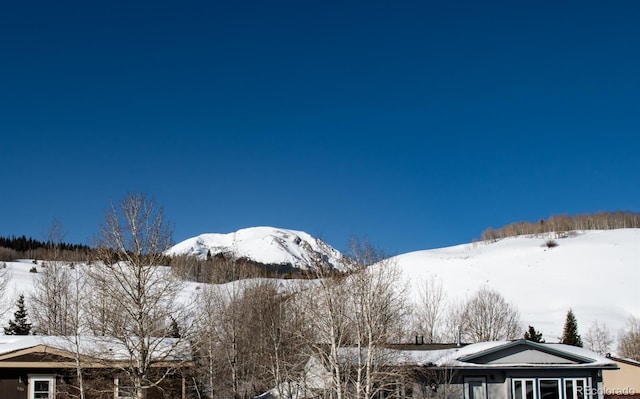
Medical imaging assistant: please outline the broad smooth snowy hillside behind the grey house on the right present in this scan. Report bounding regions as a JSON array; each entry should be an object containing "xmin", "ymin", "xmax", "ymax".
[{"xmin": 395, "ymin": 229, "xmax": 640, "ymax": 342}]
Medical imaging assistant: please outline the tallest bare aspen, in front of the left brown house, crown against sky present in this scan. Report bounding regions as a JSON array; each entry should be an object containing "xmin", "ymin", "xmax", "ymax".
[{"xmin": 90, "ymin": 194, "xmax": 187, "ymax": 399}]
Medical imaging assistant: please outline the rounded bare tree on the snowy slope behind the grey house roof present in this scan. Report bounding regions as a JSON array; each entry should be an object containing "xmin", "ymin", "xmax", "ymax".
[{"xmin": 462, "ymin": 287, "xmax": 522, "ymax": 342}]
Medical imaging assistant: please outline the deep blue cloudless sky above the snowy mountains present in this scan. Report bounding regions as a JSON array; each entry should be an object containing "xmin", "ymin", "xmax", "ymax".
[{"xmin": 0, "ymin": 0, "xmax": 640, "ymax": 254}]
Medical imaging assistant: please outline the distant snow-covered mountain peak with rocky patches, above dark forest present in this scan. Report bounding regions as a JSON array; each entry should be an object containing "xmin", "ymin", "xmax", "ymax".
[{"xmin": 167, "ymin": 227, "xmax": 343, "ymax": 270}]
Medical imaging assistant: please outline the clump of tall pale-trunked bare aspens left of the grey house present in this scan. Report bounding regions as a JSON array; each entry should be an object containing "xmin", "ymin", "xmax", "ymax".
[{"xmin": 302, "ymin": 240, "xmax": 406, "ymax": 399}]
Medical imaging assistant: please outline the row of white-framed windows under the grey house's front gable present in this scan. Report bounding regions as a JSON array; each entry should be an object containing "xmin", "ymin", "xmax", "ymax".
[{"xmin": 511, "ymin": 378, "xmax": 592, "ymax": 399}]
